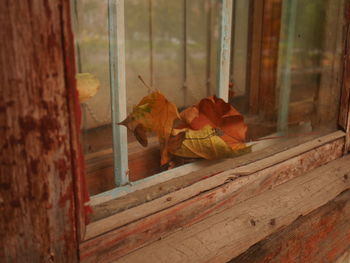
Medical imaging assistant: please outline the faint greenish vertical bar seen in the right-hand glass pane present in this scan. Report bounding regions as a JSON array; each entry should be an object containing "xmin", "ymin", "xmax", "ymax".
[{"xmin": 277, "ymin": 0, "xmax": 298, "ymax": 132}]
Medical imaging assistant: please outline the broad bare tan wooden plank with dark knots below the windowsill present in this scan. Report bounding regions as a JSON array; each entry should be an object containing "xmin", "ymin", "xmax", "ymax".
[{"xmin": 115, "ymin": 156, "xmax": 350, "ymax": 263}]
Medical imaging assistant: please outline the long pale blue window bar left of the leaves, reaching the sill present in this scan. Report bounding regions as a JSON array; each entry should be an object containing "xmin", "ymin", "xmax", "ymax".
[{"xmin": 108, "ymin": 0, "xmax": 129, "ymax": 186}]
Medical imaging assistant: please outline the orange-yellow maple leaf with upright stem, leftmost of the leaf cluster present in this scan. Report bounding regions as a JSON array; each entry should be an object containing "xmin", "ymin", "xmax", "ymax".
[{"xmin": 119, "ymin": 91, "xmax": 180, "ymax": 165}]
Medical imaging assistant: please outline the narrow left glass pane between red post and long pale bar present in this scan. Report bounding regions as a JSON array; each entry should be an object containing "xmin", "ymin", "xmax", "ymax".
[{"xmin": 72, "ymin": 0, "xmax": 115, "ymax": 195}]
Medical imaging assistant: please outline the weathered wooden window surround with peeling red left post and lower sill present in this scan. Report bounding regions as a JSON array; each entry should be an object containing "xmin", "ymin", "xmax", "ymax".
[{"xmin": 0, "ymin": 0, "xmax": 350, "ymax": 262}]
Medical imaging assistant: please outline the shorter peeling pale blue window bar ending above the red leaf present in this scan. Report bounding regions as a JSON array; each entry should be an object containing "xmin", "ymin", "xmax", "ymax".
[{"xmin": 216, "ymin": 0, "xmax": 233, "ymax": 101}]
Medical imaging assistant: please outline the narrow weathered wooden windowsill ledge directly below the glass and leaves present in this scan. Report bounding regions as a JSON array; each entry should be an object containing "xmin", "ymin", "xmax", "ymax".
[{"xmin": 84, "ymin": 131, "xmax": 345, "ymax": 243}]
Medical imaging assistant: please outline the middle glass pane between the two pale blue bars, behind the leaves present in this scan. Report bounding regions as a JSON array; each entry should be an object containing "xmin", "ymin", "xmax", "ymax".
[{"xmin": 125, "ymin": 0, "xmax": 226, "ymax": 181}]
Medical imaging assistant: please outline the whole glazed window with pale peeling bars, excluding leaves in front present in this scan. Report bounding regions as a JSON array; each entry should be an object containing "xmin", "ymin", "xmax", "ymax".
[{"xmin": 72, "ymin": 0, "xmax": 344, "ymax": 235}]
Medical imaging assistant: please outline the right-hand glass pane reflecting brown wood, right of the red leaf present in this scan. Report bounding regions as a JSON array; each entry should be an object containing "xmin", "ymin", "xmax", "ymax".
[{"xmin": 241, "ymin": 0, "xmax": 344, "ymax": 150}]
